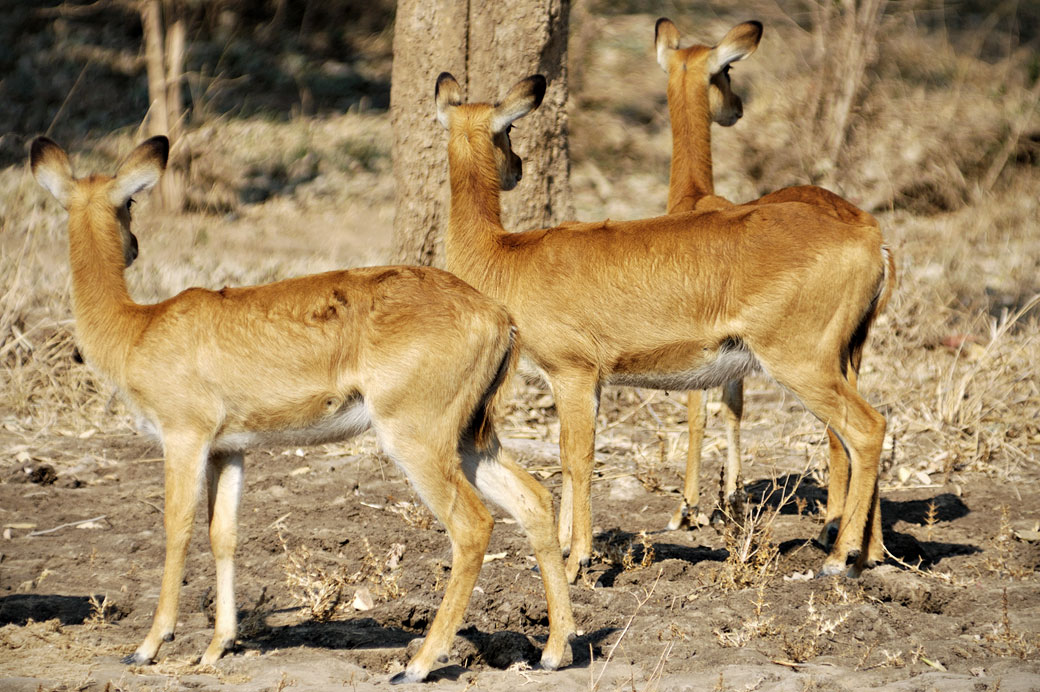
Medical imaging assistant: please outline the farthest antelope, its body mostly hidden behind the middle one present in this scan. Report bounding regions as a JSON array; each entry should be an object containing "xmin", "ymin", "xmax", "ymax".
[{"xmin": 654, "ymin": 18, "xmax": 895, "ymax": 562}]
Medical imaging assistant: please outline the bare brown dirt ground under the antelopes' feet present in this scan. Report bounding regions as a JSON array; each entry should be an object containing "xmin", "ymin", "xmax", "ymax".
[{"xmin": 0, "ymin": 383, "xmax": 1040, "ymax": 692}]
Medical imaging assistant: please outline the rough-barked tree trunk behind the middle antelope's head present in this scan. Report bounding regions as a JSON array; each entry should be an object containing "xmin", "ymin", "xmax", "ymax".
[{"xmin": 390, "ymin": 0, "xmax": 573, "ymax": 265}]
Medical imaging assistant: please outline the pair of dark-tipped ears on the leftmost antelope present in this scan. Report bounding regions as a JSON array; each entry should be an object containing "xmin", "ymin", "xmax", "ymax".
[{"xmin": 29, "ymin": 135, "xmax": 170, "ymax": 208}]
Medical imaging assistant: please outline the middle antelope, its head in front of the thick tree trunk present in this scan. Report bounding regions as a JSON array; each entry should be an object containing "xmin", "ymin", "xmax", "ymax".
[{"xmin": 435, "ymin": 73, "xmax": 890, "ymax": 580}]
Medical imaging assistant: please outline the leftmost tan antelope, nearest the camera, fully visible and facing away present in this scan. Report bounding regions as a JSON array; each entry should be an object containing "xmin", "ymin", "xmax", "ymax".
[{"xmin": 30, "ymin": 136, "xmax": 575, "ymax": 683}]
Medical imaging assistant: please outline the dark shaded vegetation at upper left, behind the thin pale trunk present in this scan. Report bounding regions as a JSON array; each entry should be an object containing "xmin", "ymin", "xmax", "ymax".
[{"xmin": 0, "ymin": 0, "xmax": 394, "ymax": 165}]
